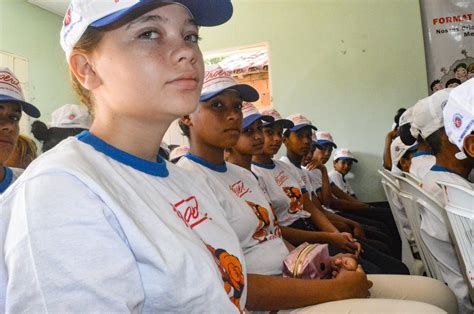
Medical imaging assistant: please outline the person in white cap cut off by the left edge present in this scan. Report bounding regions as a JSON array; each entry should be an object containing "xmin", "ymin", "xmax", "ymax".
[{"xmin": 0, "ymin": 68, "xmax": 40, "ymax": 194}]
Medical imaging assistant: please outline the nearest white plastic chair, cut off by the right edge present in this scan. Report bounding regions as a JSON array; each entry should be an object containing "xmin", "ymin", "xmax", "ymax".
[{"xmin": 438, "ymin": 182, "xmax": 474, "ymax": 302}]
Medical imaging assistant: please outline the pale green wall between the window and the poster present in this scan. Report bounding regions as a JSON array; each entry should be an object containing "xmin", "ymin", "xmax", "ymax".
[{"xmin": 201, "ymin": 0, "xmax": 427, "ymax": 201}]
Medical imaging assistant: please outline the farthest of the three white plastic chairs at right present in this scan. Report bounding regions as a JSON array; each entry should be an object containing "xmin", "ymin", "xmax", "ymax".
[{"xmin": 378, "ymin": 169, "xmax": 425, "ymax": 275}]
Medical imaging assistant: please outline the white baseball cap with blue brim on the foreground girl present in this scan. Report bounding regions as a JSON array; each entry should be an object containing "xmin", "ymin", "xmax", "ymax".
[{"xmin": 61, "ymin": 0, "xmax": 233, "ymax": 60}]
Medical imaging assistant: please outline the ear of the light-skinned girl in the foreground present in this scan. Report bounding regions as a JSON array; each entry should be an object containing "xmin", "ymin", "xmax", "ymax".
[{"xmin": 69, "ymin": 50, "xmax": 101, "ymax": 90}]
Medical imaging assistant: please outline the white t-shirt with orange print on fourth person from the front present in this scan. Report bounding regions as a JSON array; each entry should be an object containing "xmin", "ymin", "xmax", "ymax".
[{"xmin": 252, "ymin": 160, "xmax": 311, "ymax": 226}]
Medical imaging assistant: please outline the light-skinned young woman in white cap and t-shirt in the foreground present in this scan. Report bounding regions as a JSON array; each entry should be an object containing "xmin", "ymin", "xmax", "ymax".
[{"xmin": 0, "ymin": 0, "xmax": 247, "ymax": 313}]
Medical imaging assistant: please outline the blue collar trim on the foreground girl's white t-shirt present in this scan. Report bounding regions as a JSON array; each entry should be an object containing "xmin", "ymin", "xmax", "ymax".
[{"xmin": 77, "ymin": 131, "xmax": 169, "ymax": 178}]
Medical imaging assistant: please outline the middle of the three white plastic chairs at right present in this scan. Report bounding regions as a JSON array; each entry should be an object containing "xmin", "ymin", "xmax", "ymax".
[{"xmin": 396, "ymin": 176, "xmax": 444, "ymax": 282}]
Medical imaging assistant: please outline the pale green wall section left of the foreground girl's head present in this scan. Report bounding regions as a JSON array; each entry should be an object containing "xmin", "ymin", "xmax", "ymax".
[{"xmin": 0, "ymin": 0, "xmax": 77, "ymax": 122}]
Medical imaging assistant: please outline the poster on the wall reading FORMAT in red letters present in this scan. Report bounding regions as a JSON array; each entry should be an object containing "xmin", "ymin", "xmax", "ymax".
[{"xmin": 420, "ymin": 0, "xmax": 474, "ymax": 94}]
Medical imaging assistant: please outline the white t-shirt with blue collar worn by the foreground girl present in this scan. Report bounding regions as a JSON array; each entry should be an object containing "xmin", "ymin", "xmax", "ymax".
[{"xmin": 0, "ymin": 132, "xmax": 247, "ymax": 313}]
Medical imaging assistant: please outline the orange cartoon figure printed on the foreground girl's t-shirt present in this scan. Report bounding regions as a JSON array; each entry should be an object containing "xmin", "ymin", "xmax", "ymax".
[{"xmin": 206, "ymin": 244, "xmax": 245, "ymax": 310}]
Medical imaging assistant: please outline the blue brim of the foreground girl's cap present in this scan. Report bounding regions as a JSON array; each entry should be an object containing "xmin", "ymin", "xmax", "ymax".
[{"xmin": 91, "ymin": 0, "xmax": 234, "ymax": 27}]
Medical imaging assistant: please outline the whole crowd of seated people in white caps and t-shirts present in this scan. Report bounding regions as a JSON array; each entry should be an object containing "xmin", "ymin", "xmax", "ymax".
[{"xmin": 0, "ymin": 0, "xmax": 474, "ymax": 313}]
